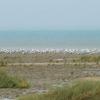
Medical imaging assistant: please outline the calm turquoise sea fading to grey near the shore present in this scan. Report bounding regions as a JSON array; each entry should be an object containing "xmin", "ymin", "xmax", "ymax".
[{"xmin": 0, "ymin": 31, "xmax": 100, "ymax": 48}]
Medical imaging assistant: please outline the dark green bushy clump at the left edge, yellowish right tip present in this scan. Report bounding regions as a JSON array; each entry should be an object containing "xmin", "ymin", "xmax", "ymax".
[{"xmin": 0, "ymin": 71, "xmax": 29, "ymax": 88}]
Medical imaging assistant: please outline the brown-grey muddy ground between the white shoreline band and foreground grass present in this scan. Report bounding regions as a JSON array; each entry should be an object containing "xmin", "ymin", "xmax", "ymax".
[{"xmin": 0, "ymin": 53, "xmax": 100, "ymax": 100}]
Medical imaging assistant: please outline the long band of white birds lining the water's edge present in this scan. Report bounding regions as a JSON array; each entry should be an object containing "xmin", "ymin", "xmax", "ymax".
[{"xmin": 0, "ymin": 48, "xmax": 100, "ymax": 54}]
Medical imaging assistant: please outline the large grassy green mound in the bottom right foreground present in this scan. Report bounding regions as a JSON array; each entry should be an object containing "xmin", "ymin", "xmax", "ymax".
[{"xmin": 18, "ymin": 80, "xmax": 100, "ymax": 100}]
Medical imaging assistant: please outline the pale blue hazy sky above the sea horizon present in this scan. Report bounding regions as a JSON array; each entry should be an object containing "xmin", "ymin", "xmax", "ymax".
[{"xmin": 0, "ymin": 0, "xmax": 100, "ymax": 30}]
